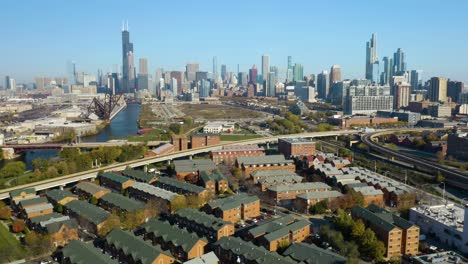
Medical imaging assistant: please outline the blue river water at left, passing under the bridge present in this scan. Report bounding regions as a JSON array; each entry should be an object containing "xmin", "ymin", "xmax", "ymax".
[{"xmin": 0, "ymin": 104, "xmax": 141, "ymax": 170}]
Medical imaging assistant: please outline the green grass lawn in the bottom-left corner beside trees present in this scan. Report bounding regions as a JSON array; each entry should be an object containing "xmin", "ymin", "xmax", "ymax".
[{"xmin": 0, "ymin": 224, "xmax": 26, "ymax": 263}]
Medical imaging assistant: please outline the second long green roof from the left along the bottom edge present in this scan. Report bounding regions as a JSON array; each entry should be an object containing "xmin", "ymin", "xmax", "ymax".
[{"xmin": 105, "ymin": 228, "xmax": 172, "ymax": 264}]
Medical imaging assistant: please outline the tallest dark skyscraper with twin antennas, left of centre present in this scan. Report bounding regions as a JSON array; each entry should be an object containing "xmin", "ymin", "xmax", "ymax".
[{"xmin": 122, "ymin": 22, "xmax": 135, "ymax": 92}]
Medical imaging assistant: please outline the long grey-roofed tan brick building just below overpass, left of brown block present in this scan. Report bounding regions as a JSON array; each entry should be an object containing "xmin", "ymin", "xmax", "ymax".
[{"xmin": 211, "ymin": 145, "xmax": 265, "ymax": 166}]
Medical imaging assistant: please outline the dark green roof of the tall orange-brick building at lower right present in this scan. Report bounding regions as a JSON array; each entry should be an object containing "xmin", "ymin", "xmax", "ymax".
[{"xmin": 351, "ymin": 205, "xmax": 413, "ymax": 232}]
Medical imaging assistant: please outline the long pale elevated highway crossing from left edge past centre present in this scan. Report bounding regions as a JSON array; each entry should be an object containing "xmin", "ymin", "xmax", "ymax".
[{"xmin": 0, "ymin": 130, "xmax": 358, "ymax": 200}]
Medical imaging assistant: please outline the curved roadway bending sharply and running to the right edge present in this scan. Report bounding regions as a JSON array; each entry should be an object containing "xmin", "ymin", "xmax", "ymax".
[{"xmin": 361, "ymin": 131, "xmax": 468, "ymax": 190}]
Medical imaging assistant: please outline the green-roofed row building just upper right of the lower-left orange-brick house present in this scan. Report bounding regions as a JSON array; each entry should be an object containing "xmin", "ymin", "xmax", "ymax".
[{"xmin": 64, "ymin": 200, "xmax": 110, "ymax": 234}]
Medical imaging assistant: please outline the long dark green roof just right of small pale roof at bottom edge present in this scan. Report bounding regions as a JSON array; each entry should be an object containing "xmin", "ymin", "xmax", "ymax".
[{"xmin": 214, "ymin": 236, "xmax": 296, "ymax": 264}]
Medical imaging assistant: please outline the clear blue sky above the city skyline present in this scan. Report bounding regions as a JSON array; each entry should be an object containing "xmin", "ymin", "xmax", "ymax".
[{"xmin": 0, "ymin": 0, "xmax": 468, "ymax": 85}]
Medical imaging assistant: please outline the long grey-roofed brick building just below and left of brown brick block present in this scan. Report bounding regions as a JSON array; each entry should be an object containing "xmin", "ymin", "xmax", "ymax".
[{"xmin": 236, "ymin": 155, "xmax": 296, "ymax": 178}]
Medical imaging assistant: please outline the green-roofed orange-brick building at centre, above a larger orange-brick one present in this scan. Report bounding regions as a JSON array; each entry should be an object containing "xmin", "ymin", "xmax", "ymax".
[{"xmin": 204, "ymin": 193, "xmax": 260, "ymax": 223}]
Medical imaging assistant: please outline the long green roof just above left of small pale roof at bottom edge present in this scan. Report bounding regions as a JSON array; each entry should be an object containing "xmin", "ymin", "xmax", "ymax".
[{"xmin": 142, "ymin": 219, "xmax": 208, "ymax": 252}]
